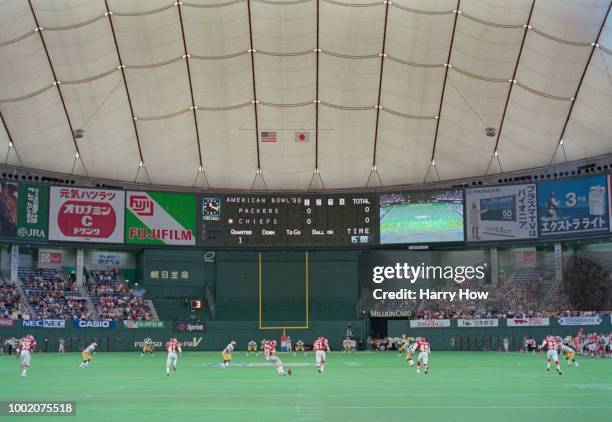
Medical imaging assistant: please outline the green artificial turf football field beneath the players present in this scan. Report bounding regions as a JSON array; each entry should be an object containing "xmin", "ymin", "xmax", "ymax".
[{"xmin": 0, "ymin": 351, "xmax": 612, "ymax": 422}]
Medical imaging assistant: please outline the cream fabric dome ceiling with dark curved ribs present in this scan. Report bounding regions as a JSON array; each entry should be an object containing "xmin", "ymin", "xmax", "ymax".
[{"xmin": 0, "ymin": 0, "xmax": 612, "ymax": 190}]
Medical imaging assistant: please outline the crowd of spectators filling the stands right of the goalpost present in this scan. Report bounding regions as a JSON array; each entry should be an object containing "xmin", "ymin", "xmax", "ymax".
[{"xmin": 366, "ymin": 259, "xmax": 612, "ymax": 319}]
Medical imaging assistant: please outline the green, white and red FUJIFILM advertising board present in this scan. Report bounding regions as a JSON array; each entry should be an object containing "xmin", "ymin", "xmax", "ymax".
[{"xmin": 125, "ymin": 192, "xmax": 197, "ymax": 246}]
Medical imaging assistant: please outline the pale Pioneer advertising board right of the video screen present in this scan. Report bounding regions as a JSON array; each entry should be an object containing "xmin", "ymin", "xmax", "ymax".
[{"xmin": 465, "ymin": 183, "xmax": 538, "ymax": 242}]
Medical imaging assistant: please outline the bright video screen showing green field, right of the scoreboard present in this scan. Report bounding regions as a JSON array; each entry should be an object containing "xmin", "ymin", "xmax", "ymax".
[{"xmin": 380, "ymin": 202, "xmax": 463, "ymax": 244}]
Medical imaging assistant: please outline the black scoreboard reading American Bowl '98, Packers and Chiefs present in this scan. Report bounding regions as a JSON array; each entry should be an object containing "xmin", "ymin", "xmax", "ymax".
[{"xmin": 197, "ymin": 193, "xmax": 379, "ymax": 246}]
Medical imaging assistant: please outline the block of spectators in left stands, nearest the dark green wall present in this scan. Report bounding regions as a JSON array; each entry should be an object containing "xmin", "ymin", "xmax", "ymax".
[{"xmin": 87, "ymin": 269, "xmax": 154, "ymax": 321}]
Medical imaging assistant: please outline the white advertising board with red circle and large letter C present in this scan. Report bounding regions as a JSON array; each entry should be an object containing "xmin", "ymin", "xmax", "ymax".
[{"xmin": 49, "ymin": 186, "xmax": 125, "ymax": 243}]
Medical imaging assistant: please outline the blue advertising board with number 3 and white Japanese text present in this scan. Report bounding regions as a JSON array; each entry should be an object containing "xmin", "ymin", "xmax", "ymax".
[{"xmin": 538, "ymin": 176, "xmax": 610, "ymax": 237}]
